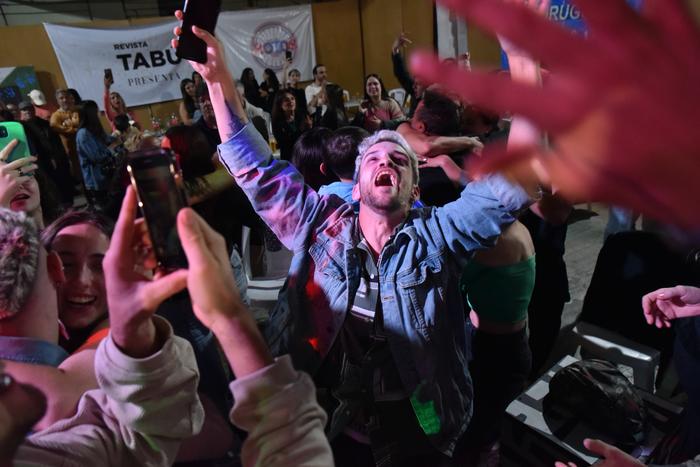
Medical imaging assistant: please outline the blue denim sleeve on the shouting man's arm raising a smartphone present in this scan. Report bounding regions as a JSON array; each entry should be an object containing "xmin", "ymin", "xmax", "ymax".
[{"xmin": 219, "ymin": 124, "xmax": 340, "ymax": 251}]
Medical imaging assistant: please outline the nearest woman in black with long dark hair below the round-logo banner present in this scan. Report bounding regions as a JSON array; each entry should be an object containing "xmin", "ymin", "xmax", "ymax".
[{"xmin": 272, "ymin": 89, "xmax": 312, "ymax": 161}]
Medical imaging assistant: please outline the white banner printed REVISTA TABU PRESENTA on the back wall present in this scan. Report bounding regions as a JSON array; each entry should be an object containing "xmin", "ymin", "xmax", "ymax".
[{"xmin": 44, "ymin": 20, "xmax": 192, "ymax": 108}]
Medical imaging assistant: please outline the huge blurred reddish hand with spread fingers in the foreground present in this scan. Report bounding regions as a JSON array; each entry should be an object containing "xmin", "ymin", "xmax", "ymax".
[{"xmin": 412, "ymin": 0, "xmax": 700, "ymax": 227}]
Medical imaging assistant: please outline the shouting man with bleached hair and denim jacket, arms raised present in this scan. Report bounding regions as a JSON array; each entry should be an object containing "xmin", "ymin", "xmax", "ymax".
[{"xmin": 182, "ymin": 29, "xmax": 530, "ymax": 466}]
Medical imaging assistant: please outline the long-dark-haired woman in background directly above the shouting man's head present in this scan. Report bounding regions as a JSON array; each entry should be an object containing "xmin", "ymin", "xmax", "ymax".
[{"xmin": 352, "ymin": 73, "xmax": 404, "ymax": 132}]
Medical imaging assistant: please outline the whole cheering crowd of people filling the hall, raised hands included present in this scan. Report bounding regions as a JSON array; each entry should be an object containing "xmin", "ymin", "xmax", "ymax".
[{"xmin": 0, "ymin": 0, "xmax": 700, "ymax": 467}]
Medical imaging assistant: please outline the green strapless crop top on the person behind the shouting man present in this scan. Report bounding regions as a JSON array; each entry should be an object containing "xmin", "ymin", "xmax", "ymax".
[{"xmin": 460, "ymin": 255, "xmax": 535, "ymax": 323}]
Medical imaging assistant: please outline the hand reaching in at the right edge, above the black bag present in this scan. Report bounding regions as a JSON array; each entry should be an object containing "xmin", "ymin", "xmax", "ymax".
[{"xmin": 642, "ymin": 285, "xmax": 700, "ymax": 328}]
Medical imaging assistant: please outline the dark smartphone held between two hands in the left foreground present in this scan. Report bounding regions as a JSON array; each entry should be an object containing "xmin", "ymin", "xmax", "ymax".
[{"xmin": 126, "ymin": 148, "xmax": 187, "ymax": 270}]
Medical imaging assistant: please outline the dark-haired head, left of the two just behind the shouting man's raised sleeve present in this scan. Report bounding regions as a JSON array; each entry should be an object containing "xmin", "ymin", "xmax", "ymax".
[{"xmin": 292, "ymin": 127, "xmax": 336, "ymax": 191}]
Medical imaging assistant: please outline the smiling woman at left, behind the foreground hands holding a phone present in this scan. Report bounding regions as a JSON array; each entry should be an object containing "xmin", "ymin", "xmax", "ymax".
[{"xmin": 41, "ymin": 210, "xmax": 114, "ymax": 353}]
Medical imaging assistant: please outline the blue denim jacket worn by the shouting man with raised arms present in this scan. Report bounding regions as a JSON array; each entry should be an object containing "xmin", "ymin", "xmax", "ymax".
[{"xmin": 219, "ymin": 125, "xmax": 530, "ymax": 455}]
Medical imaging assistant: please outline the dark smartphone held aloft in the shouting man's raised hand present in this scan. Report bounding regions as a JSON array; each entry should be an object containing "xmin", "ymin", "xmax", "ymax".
[{"xmin": 175, "ymin": 0, "xmax": 221, "ymax": 63}]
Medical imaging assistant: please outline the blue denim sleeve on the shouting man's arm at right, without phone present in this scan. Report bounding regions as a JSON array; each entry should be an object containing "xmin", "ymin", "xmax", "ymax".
[{"xmin": 434, "ymin": 175, "xmax": 533, "ymax": 255}]
